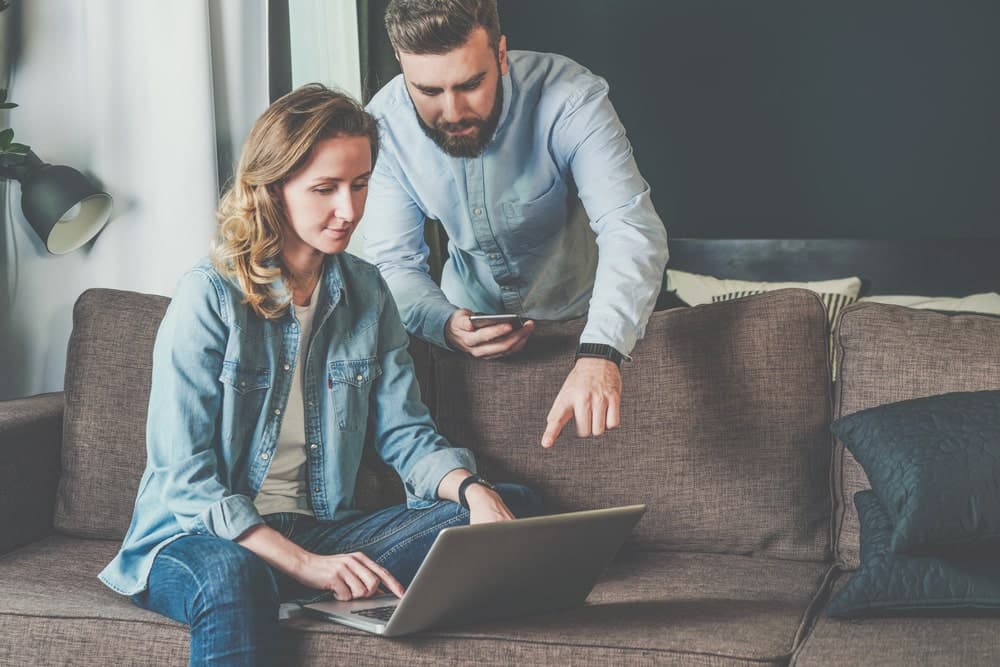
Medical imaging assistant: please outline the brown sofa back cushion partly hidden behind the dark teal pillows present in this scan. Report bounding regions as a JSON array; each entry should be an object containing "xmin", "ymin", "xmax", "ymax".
[{"xmin": 833, "ymin": 303, "xmax": 1000, "ymax": 569}]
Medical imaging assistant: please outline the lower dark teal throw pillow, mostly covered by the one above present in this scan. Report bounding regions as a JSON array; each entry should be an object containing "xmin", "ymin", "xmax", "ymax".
[{"xmin": 826, "ymin": 491, "xmax": 1000, "ymax": 617}]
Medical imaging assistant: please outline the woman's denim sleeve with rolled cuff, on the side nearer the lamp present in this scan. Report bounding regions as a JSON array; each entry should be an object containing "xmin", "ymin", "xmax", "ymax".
[{"xmin": 146, "ymin": 269, "xmax": 263, "ymax": 540}]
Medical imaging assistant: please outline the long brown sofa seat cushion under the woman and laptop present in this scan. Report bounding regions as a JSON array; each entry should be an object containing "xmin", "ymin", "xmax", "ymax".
[{"xmin": 0, "ymin": 536, "xmax": 828, "ymax": 667}]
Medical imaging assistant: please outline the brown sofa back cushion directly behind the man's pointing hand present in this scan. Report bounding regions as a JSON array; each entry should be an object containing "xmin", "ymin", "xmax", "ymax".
[{"xmin": 434, "ymin": 290, "xmax": 832, "ymax": 560}]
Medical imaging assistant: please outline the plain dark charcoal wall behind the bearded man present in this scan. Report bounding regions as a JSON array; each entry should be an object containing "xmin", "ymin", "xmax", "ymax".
[{"xmin": 369, "ymin": 0, "xmax": 1000, "ymax": 238}]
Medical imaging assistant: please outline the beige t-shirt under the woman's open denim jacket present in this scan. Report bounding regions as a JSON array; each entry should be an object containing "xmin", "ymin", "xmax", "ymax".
[{"xmin": 253, "ymin": 275, "xmax": 323, "ymax": 516}]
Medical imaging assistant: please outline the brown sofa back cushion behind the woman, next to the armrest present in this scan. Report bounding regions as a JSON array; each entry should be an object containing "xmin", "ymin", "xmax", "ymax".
[{"xmin": 54, "ymin": 289, "xmax": 400, "ymax": 539}]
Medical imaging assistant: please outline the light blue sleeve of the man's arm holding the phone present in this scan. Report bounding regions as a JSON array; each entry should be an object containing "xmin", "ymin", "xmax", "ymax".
[{"xmin": 361, "ymin": 151, "xmax": 455, "ymax": 348}]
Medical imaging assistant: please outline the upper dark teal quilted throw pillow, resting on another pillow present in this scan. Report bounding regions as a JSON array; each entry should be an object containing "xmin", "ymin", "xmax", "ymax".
[{"xmin": 831, "ymin": 391, "xmax": 1000, "ymax": 555}]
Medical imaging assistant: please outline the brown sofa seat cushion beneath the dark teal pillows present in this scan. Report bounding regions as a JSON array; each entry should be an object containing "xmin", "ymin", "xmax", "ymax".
[{"xmin": 791, "ymin": 574, "xmax": 1000, "ymax": 667}]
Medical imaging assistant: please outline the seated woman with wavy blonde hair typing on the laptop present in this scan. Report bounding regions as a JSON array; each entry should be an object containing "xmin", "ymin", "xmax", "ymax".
[{"xmin": 100, "ymin": 85, "xmax": 538, "ymax": 664}]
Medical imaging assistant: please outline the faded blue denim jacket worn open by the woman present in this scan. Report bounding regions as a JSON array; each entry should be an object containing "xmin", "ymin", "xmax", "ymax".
[{"xmin": 99, "ymin": 254, "xmax": 475, "ymax": 595}]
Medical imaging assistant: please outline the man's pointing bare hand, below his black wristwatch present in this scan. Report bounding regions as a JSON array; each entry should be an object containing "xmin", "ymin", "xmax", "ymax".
[{"xmin": 542, "ymin": 357, "xmax": 622, "ymax": 447}]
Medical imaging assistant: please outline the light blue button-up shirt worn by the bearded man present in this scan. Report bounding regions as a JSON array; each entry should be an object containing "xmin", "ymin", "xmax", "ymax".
[{"xmin": 361, "ymin": 51, "xmax": 667, "ymax": 354}]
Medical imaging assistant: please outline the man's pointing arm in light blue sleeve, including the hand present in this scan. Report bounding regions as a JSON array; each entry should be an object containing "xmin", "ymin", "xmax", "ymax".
[{"xmin": 542, "ymin": 80, "xmax": 667, "ymax": 447}]
